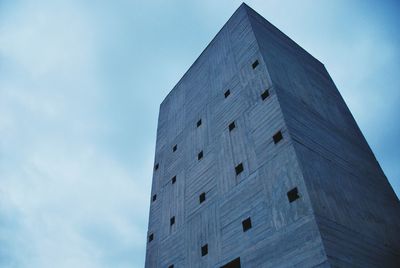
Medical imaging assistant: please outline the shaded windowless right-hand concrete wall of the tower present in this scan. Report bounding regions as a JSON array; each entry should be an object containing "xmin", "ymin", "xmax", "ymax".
[{"xmin": 249, "ymin": 6, "xmax": 400, "ymax": 267}]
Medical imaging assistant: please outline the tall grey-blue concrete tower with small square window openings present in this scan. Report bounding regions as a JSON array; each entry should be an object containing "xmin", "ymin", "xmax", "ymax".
[{"xmin": 146, "ymin": 4, "xmax": 400, "ymax": 268}]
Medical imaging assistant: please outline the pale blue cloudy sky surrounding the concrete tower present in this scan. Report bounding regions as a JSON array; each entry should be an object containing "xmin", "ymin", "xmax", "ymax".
[{"xmin": 0, "ymin": 0, "xmax": 400, "ymax": 268}]
